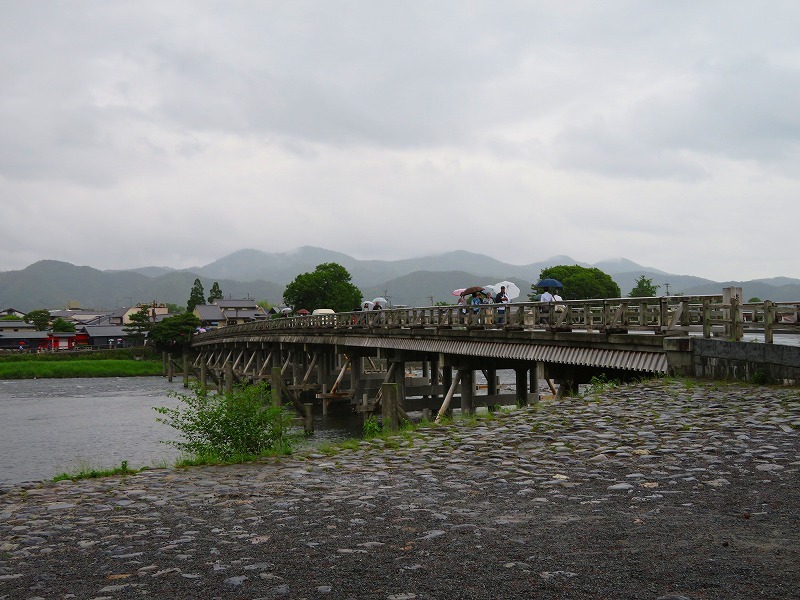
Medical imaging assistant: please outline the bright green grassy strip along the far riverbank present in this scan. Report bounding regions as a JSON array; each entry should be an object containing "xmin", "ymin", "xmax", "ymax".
[{"xmin": 0, "ymin": 348, "xmax": 162, "ymax": 379}]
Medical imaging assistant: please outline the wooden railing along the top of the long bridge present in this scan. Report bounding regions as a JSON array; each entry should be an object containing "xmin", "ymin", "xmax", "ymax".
[{"xmin": 194, "ymin": 295, "xmax": 800, "ymax": 343}]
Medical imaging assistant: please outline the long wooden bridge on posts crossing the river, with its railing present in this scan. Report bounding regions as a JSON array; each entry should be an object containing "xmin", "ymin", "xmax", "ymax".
[{"xmin": 183, "ymin": 295, "xmax": 800, "ymax": 426}]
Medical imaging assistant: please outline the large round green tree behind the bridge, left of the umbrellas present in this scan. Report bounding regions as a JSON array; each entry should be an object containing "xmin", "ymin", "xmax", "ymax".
[{"xmin": 283, "ymin": 263, "xmax": 361, "ymax": 312}]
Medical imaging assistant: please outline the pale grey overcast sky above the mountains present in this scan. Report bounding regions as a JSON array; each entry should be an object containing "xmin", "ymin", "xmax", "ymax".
[{"xmin": 0, "ymin": 0, "xmax": 800, "ymax": 281}]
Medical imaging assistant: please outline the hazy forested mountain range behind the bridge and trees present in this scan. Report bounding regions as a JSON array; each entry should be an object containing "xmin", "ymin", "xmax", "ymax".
[{"xmin": 0, "ymin": 246, "xmax": 800, "ymax": 312}]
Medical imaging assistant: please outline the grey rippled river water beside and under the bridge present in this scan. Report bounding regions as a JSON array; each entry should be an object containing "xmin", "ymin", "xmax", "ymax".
[{"xmin": 0, "ymin": 377, "xmax": 362, "ymax": 485}]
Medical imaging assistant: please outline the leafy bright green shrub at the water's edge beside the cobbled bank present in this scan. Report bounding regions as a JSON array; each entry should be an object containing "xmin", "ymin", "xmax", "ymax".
[{"xmin": 155, "ymin": 382, "xmax": 297, "ymax": 462}]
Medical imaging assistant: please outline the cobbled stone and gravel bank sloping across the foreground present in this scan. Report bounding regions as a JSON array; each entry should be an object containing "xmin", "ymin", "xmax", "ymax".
[{"xmin": 0, "ymin": 380, "xmax": 800, "ymax": 600}]
